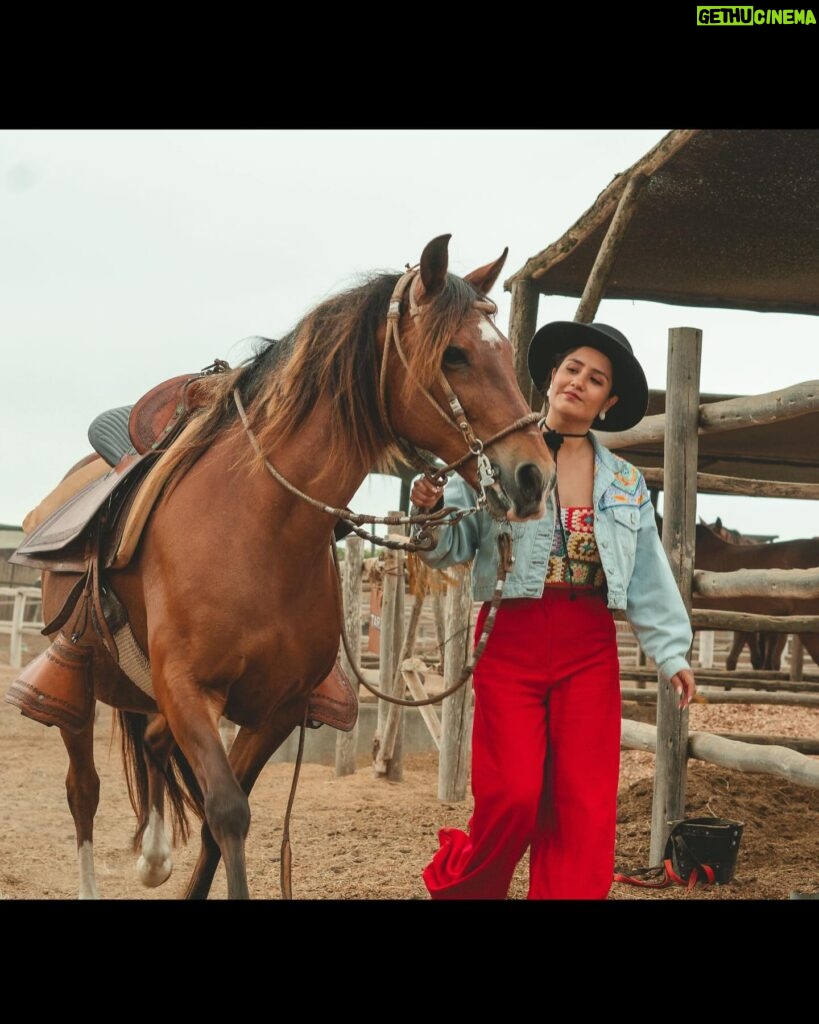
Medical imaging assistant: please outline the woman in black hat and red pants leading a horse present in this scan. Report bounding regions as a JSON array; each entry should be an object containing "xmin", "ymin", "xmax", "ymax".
[{"xmin": 412, "ymin": 322, "xmax": 696, "ymax": 899}]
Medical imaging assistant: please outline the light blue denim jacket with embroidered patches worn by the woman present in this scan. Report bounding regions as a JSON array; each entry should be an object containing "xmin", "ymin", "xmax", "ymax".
[{"xmin": 419, "ymin": 433, "xmax": 693, "ymax": 680}]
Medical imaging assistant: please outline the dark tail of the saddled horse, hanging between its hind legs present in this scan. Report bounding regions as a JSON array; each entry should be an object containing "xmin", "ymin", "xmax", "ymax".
[{"xmin": 117, "ymin": 711, "xmax": 205, "ymax": 852}]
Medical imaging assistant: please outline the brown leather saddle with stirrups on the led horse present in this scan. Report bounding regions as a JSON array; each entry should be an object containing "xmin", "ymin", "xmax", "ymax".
[{"xmin": 6, "ymin": 368, "xmax": 358, "ymax": 732}]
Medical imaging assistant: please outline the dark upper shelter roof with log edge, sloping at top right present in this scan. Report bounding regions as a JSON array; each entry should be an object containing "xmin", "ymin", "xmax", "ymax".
[{"xmin": 505, "ymin": 129, "xmax": 819, "ymax": 313}]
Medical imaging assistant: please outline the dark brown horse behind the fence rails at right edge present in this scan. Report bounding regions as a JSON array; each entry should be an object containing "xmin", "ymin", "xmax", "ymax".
[{"xmin": 693, "ymin": 520, "xmax": 819, "ymax": 668}]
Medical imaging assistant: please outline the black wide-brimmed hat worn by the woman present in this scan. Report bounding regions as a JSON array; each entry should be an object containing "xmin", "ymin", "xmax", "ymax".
[{"xmin": 528, "ymin": 321, "xmax": 648, "ymax": 430}]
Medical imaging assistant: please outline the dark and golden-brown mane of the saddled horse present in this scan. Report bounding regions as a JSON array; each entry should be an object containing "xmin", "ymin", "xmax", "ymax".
[{"xmin": 156, "ymin": 264, "xmax": 482, "ymax": 481}]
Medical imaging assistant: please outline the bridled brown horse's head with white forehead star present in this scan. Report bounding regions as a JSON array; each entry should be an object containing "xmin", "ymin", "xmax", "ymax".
[{"xmin": 381, "ymin": 234, "xmax": 555, "ymax": 519}]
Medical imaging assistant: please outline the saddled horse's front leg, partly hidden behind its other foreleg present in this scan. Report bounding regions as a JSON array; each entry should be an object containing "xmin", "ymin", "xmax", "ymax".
[{"xmin": 185, "ymin": 702, "xmax": 304, "ymax": 899}]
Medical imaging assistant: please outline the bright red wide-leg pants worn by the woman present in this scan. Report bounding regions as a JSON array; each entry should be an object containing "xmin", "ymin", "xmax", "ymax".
[{"xmin": 423, "ymin": 587, "xmax": 621, "ymax": 899}]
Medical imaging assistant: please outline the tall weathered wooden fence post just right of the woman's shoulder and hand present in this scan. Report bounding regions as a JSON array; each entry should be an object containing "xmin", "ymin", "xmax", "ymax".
[{"xmin": 649, "ymin": 327, "xmax": 702, "ymax": 864}]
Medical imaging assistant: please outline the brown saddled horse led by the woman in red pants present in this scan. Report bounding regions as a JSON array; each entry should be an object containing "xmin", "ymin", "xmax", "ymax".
[{"xmin": 30, "ymin": 234, "xmax": 555, "ymax": 899}]
